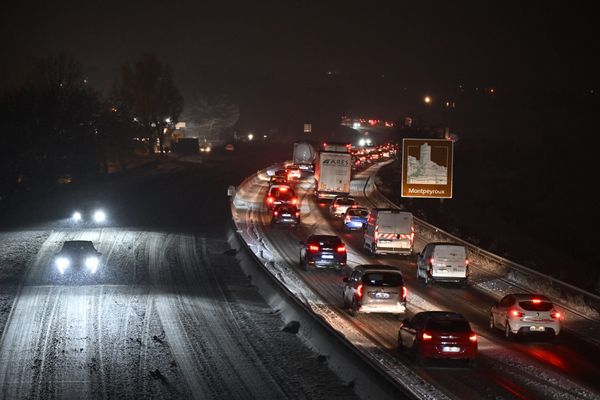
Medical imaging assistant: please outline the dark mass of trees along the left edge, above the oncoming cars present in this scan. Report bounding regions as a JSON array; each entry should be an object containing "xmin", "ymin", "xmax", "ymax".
[{"xmin": 0, "ymin": 54, "xmax": 183, "ymax": 204}]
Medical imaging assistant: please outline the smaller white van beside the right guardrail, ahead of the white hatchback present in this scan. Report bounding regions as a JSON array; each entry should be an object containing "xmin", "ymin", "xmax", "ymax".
[{"xmin": 417, "ymin": 243, "xmax": 469, "ymax": 285}]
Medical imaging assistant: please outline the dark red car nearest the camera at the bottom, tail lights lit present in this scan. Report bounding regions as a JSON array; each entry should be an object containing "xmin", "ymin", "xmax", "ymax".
[{"xmin": 398, "ymin": 311, "xmax": 477, "ymax": 365}]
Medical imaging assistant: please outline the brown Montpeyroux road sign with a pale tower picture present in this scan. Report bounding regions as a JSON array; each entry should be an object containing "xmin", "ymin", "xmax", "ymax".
[{"xmin": 402, "ymin": 139, "xmax": 454, "ymax": 199}]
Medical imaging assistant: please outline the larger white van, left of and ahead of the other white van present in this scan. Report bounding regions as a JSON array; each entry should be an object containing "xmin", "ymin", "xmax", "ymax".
[{"xmin": 363, "ymin": 208, "xmax": 415, "ymax": 255}]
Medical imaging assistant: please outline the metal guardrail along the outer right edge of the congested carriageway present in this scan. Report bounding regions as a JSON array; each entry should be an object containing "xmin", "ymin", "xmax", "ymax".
[{"xmin": 365, "ymin": 169, "xmax": 600, "ymax": 322}]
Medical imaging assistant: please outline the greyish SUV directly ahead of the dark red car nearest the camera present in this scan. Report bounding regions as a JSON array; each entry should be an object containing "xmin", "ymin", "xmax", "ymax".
[{"xmin": 342, "ymin": 264, "xmax": 408, "ymax": 314}]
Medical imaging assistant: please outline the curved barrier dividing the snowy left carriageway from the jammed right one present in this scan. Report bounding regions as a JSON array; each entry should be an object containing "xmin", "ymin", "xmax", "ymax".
[{"xmin": 227, "ymin": 178, "xmax": 419, "ymax": 400}]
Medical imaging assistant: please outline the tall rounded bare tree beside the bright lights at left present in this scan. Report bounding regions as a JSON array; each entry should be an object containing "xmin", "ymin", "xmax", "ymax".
[{"xmin": 111, "ymin": 54, "xmax": 183, "ymax": 153}]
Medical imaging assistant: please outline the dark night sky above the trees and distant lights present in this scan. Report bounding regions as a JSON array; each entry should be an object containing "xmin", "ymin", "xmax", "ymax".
[{"xmin": 0, "ymin": 1, "xmax": 598, "ymax": 122}]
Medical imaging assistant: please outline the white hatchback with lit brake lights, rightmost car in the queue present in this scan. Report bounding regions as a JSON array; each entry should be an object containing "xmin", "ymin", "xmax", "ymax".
[{"xmin": 489, "ymin": 293, "xmax": 564, "ymax": 339}]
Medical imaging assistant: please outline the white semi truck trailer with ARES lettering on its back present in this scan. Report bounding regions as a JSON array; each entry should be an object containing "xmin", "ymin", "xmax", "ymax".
[{"xmin": 315, "ymin": 151, "xmax": 352, "ymax": 199}]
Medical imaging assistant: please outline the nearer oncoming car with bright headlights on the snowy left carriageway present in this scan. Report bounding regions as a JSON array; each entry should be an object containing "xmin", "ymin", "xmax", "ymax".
[{"xmin": 53, "ymin": 240, "xmax": 101, "ymax": 275}]
